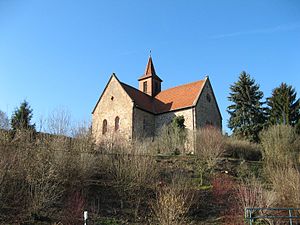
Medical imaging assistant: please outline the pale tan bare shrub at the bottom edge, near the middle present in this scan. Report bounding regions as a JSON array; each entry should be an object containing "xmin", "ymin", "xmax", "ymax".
[{"xmin": 152, "ymin": 176, "xmax": 193, "ymax": 225}]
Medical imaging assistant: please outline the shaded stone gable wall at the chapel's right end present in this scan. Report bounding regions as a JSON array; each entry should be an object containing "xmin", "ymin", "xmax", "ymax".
[{"xmin": 196, "ymin": 80, "xmax": 222, "ymax": 130}]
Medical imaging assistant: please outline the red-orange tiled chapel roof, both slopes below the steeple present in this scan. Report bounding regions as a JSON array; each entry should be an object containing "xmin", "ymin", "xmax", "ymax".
[{"xmin": 121, "ymin": 80, "xmax": 205, "ymax": 114}]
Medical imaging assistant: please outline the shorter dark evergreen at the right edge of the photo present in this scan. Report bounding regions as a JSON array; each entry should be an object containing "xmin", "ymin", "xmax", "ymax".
[{"xmin": 267, "ymin": 83, "xmax": 300, "ymax": 126}]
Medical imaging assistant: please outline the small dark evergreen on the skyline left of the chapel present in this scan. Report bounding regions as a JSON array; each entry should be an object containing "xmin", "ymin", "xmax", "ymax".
[{"xmin": 10, "ymin": 101, "xmax": 35, "ymax": 131}]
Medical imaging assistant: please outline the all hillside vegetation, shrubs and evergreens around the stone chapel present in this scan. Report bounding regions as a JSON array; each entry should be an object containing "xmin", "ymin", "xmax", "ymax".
[{"xmin": 0, "ymin": 72, "xmax": 300, "ymax": 225}]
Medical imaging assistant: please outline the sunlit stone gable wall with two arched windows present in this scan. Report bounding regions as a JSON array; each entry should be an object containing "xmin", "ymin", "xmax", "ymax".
[{"xmin": 92, "ymin": 76, "xmax": 133, "ymax": 143}]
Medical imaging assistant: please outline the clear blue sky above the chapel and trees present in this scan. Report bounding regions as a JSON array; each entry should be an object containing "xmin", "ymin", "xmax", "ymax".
[{"xmin": 0, "ymin": 0, "xmax": 300, "ymax": 130}]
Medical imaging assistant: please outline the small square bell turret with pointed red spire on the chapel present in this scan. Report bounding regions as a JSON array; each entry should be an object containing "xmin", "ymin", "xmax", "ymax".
[{"xmin": 138, "ymin": 53, "xmax": 162, "ymax": 97}]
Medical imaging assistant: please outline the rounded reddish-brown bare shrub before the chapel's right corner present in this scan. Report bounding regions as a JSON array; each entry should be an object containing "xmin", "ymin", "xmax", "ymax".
[{"xmin": 195, "ymin": 127, "xmax": 225, "ymax": 185}]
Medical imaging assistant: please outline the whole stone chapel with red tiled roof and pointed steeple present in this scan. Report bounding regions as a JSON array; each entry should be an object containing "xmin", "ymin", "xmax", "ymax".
[{"xmin": 92, "ymin": 56, "xmax": 222, "ymax": 143}]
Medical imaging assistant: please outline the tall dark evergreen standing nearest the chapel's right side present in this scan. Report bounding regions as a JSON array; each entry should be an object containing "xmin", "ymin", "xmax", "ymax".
[{"xmin": 227, "ymin": 71, "xmax": 265, "ymax": 142}]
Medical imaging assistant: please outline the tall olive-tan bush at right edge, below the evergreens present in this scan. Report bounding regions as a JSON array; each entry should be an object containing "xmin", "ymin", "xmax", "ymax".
[{"xmin": 261, "ymin": 125, "xmax": 300, "ymax": 207}]
